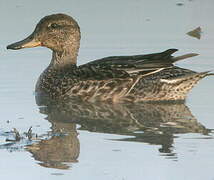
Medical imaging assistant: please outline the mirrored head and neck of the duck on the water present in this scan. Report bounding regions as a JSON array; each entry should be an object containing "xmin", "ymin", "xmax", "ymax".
[{"xmin": 26, "ymin": 122, "xmax": 80, "ymax": 169}]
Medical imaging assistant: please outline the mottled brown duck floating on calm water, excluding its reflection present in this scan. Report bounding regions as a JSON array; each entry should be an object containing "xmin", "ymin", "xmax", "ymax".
[{"xmin": 7, "ymin": 13, "xmax": 213, "ymax": 103}]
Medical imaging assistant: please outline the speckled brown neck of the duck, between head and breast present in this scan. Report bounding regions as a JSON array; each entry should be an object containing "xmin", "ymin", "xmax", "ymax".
[{"xmin": 49, "ymin": 45, "xmax": 79, "ymax": 68}]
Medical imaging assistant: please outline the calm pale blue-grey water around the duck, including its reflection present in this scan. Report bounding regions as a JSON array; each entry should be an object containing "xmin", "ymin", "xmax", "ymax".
[{"xmin": 0, "ymin": 0, "xmax": 214, "ymax": 180}]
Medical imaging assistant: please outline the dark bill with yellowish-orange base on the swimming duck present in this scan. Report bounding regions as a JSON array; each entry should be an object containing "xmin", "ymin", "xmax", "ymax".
[{"xmin": 7, "ymin": 35, "xmax": 41, "ymax": 50}]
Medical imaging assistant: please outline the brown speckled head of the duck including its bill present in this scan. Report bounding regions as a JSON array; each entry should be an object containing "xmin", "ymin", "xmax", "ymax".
[{"xmin": 7, "ymin": 14, "xmax": 80, "ymax": 53}]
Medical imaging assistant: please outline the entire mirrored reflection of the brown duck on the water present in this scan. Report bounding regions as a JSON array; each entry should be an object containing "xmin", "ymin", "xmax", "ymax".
[{"xmin": 24, "ymin": 98, "xmax": 210, "ymax": 169}]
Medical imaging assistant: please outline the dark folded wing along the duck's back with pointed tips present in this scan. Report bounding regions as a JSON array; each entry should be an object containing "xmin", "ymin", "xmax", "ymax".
[{"xmin": 82, "ymin": 49, "xmax": 197, "ymax": 76}]
